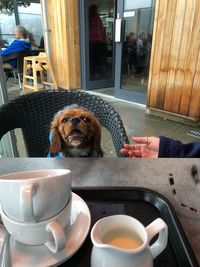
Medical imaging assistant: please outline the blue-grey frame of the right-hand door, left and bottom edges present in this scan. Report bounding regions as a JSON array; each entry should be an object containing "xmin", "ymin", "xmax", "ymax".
[{"xmin": 115, "ymin": 0, "xmax": 147, "ymax": 104}]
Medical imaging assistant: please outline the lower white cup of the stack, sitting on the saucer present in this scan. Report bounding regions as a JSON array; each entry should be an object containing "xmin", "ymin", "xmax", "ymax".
[{"xmin": 0, "ymin": 198, "xmax": 72, "ymax": 253}]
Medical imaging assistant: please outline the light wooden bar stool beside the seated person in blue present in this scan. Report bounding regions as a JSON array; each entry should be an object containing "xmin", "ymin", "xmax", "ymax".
[{"xmin": 22, "ymin": 52, "xmax": 58, "ymax": 93}]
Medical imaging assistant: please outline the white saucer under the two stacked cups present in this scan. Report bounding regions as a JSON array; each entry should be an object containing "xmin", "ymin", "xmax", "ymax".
[{"xmin": 0, "ymin": 193, "xmax": 91, "ymax": 267}]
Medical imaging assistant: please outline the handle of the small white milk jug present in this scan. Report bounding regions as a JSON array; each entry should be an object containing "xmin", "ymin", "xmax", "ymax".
[{"xmin": 146, "ymin": 218, "xmax": 168, "ymax": 259}]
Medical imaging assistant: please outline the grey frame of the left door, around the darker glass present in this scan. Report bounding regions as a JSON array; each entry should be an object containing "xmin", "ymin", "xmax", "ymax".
[{"xmin": 78, "ymin": 0, "xmax": 115, "ymax": 90}]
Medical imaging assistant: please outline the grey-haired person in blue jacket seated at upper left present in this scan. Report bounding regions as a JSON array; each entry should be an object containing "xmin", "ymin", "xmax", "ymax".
[{"xmin": 0, "ymin": 25, "xmax": 35, "ymax": 69}]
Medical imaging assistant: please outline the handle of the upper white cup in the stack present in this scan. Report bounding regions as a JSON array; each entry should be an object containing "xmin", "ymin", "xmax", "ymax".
[{"xmin": 20, "ymin": 184, "xmax": 36, "ymax": 222}]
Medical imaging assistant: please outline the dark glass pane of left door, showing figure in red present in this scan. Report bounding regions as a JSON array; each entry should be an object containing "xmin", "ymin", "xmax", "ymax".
[{"xmin": 88, "ymin": 0, "xmax": 115, "ymax": 81}]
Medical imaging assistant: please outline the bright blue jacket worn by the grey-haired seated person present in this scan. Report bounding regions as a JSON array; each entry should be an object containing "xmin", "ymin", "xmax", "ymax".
[{"xmin": 0, "ymin": 39, "xmax": 31, "ymax": 68}]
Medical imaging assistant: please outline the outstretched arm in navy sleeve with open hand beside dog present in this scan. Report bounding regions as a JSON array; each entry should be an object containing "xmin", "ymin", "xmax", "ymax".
[{"xmin": 120, "ymin": 136, "xmax": 200, "ymax": 158}]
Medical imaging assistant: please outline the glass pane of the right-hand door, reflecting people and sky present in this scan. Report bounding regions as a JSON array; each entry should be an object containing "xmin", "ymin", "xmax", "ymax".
[{"xmin": 121, "ymin": 0, "xmax": 155, "ymax": 93}]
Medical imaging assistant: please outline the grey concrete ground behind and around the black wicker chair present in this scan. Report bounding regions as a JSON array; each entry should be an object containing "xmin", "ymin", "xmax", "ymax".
[{"xmin": 4, "ymin": 78, "xmax": 200, "ymax": 157}]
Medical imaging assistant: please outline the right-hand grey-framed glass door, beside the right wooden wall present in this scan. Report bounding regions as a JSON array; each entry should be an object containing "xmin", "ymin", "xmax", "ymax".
[{"xmin": 115, "ymin": 0, "xmax": 155, "ymax": 104}]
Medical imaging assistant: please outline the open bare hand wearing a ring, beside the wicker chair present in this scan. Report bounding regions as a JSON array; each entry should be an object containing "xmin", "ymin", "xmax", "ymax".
[{"xmin": 120, "ymin": 136, "xmax": 160, "ymax": 158}]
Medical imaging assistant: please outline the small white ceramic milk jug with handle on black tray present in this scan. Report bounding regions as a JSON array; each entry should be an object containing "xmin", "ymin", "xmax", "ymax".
[{"xmin": 91, "ymin": 215, "xmax": 168, "ymax": 267}]
